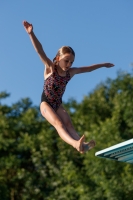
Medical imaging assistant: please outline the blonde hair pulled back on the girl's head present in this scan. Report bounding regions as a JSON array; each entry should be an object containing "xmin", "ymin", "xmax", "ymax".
[{"xmin": 53, "ymin": 46, "xmax": 75, "ymax": 64}]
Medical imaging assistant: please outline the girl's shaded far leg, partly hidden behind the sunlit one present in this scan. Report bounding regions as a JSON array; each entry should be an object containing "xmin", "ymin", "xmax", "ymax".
[{"xmin": 57, "ymin": 105, "xmax": 95, "ymax": 151}]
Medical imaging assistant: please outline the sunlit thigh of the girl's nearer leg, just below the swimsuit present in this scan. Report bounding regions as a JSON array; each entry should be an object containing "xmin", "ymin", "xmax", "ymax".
[{"xmin": 40, "ymin": 102, "xmax": 61, "ymax": 126}]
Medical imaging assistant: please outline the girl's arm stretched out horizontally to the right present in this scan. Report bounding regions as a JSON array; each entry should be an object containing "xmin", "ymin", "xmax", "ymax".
[{"xmin": 70, "ymin": 63, "xmax": 114, "ymax": 76}]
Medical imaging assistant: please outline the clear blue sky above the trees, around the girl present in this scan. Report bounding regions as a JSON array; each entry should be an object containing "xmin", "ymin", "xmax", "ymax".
[{"xmin": 0, "ymin": 0, "xmax": 133, "ymax": 105}]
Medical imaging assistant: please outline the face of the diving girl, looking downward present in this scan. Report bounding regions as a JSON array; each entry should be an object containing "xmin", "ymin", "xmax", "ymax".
[{"xmin": 58, "ymin": 53, "xmax": 74, "ymax": 71}]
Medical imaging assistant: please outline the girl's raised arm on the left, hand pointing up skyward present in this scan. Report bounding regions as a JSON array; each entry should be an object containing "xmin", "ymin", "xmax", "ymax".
[{"xmin": 23, "ymin": 21, "xmax": 52, "ymax": 67}]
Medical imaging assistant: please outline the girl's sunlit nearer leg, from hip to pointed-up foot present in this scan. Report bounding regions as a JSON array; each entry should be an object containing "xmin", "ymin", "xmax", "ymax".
[{"xmin": 40, "ymin": 102, "xmax": 84, "ymax": 152}]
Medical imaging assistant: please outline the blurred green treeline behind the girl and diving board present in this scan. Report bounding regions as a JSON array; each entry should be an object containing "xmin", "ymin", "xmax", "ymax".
[{"xmin": 0, "ymin": 73, "xmax": 133, "ymax": 200}]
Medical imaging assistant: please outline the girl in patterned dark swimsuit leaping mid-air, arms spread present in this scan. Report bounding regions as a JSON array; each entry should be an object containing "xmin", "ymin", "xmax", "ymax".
[{"xmin": 23, "ymin": 21, "xmax": 114, "ymax": 153}]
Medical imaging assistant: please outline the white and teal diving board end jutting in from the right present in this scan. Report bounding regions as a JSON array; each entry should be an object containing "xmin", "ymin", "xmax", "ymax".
[{"xmin": 95, "ymin": 139, "xmax": 133, "ymax": 163}]
